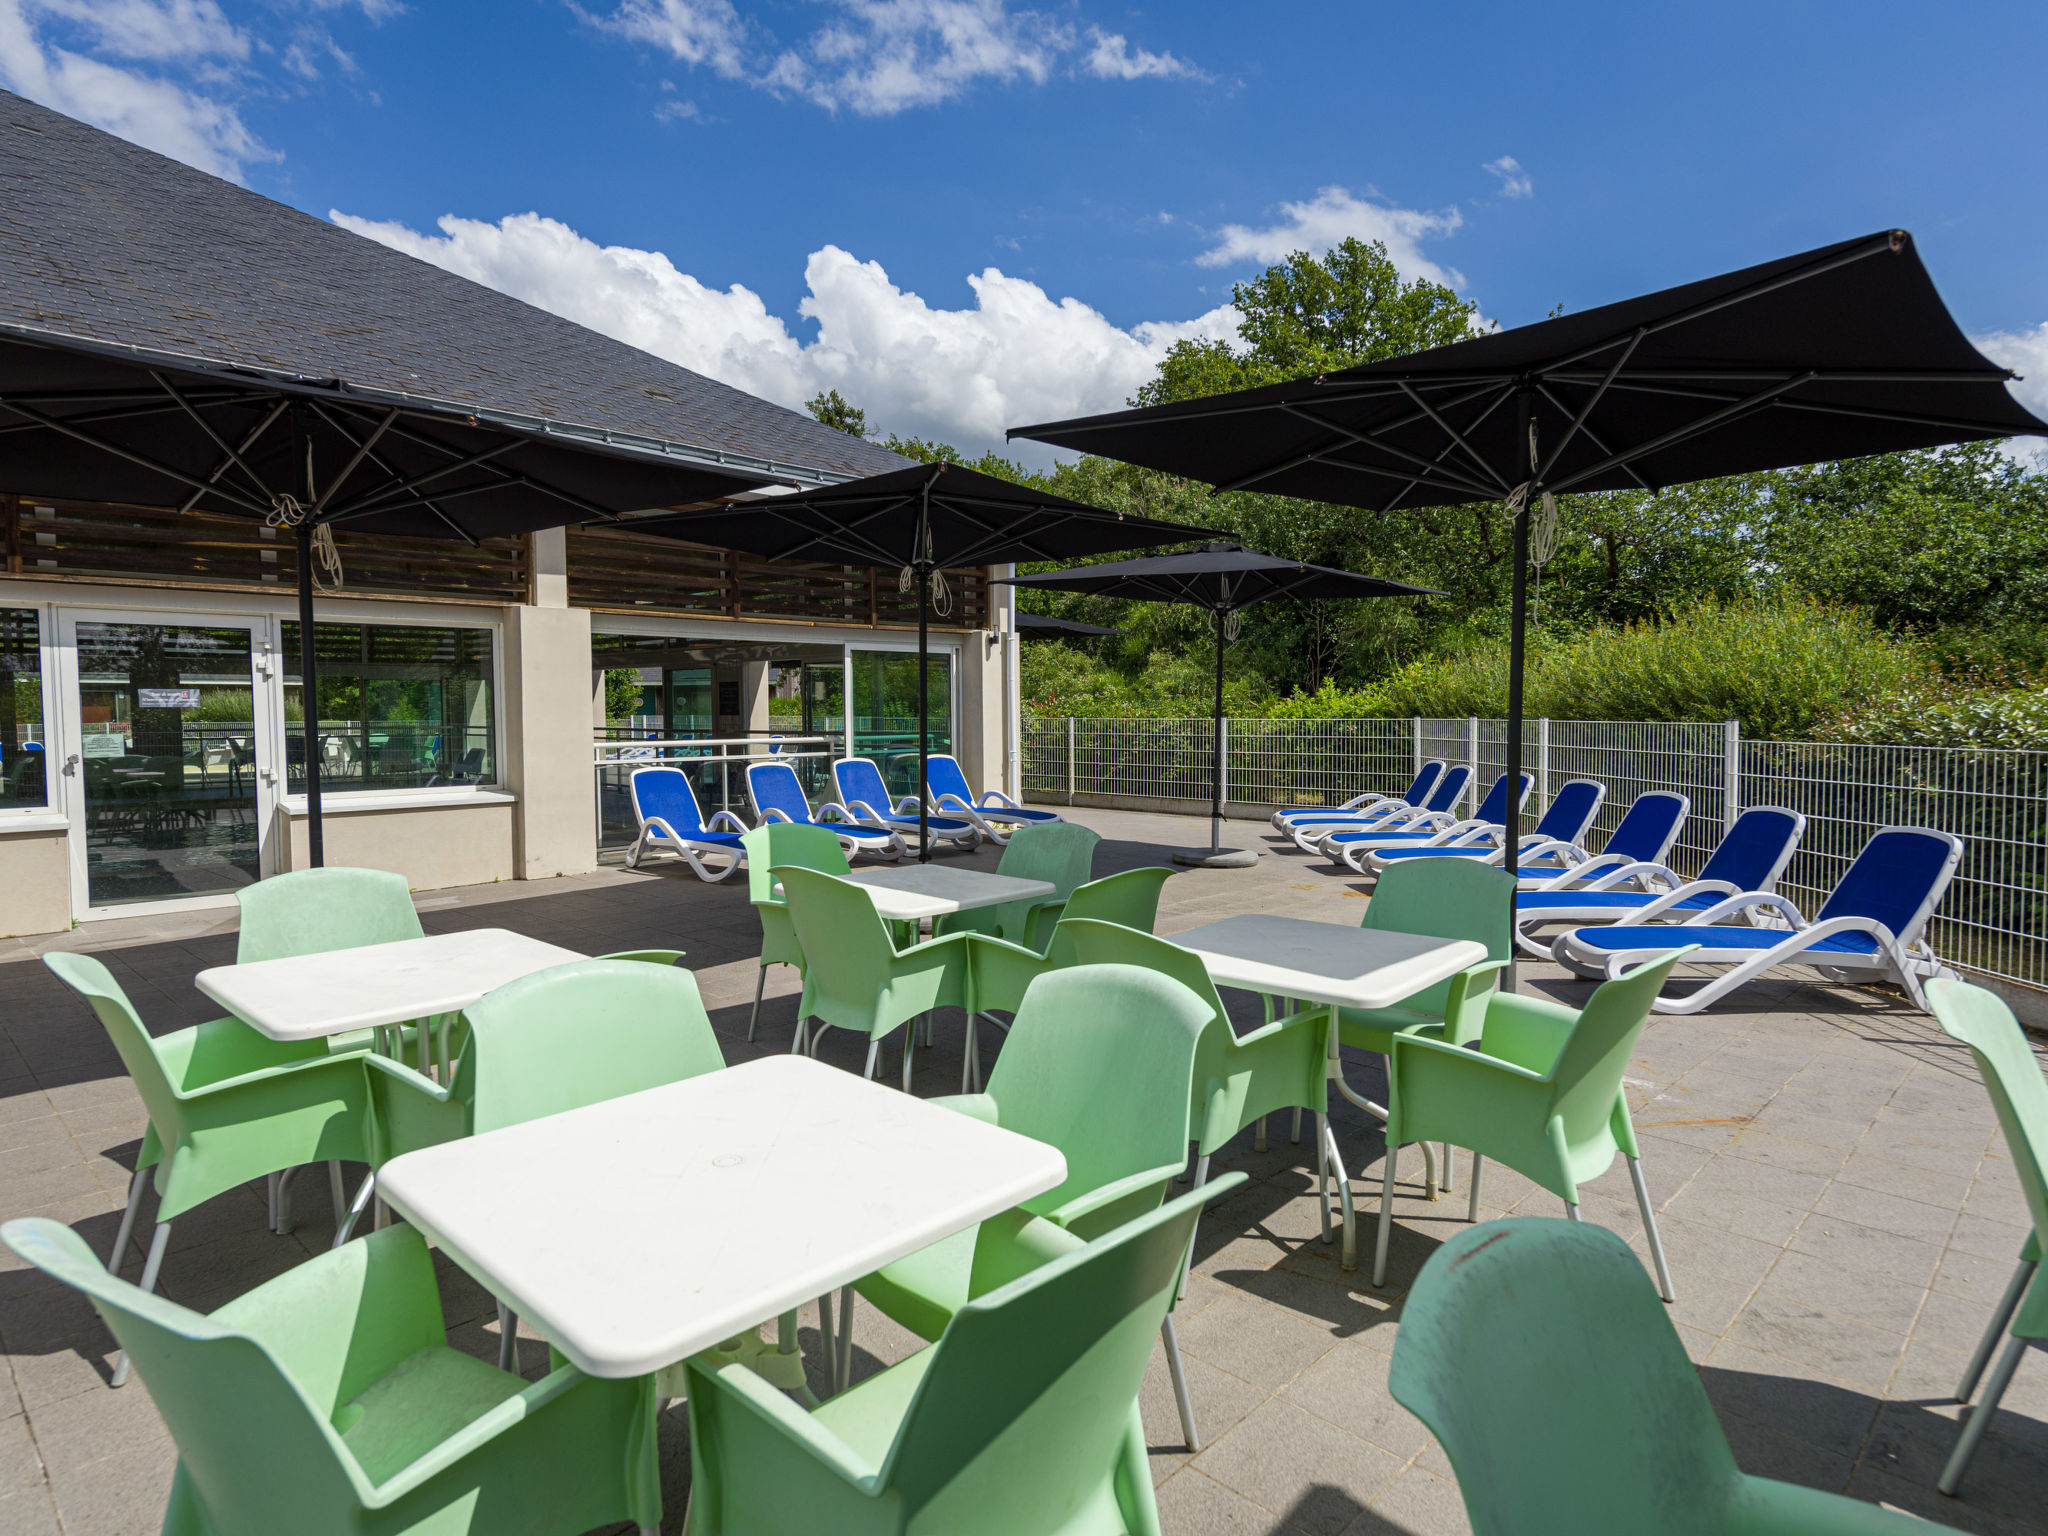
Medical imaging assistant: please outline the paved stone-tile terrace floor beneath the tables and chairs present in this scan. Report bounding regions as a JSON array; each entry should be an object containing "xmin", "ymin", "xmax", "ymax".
[{"xmin": 0, "ymin": 811, "xmax": 2048, "ymax": 1536}]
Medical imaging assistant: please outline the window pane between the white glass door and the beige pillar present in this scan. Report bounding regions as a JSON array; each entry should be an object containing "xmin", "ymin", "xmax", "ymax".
[{"xmin": 285, "ymin": 623, "xmax": 498, "ymax": 791}]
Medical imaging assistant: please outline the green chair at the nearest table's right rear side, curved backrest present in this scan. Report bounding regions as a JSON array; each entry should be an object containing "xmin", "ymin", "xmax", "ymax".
[{"xmin": 838, "ymin": 965, "xmax": 1210, "ymax": 1452}]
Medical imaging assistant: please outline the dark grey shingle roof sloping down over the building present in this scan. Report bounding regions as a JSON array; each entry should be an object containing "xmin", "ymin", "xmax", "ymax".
[{"xmin": 0, "ymin": 92, "xmax": 903, "ymax": 481}]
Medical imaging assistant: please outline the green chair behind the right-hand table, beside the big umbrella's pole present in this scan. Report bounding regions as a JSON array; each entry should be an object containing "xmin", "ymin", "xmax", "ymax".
[{"xmin": 1337, "ymin": 858, "xmax": 1516, "ymax": 1200}]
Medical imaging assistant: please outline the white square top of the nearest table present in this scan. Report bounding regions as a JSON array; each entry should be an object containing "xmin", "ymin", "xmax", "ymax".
[{"xmin": 377, "ymin": 1055, "xmax": 1067, "ymax": 1376}]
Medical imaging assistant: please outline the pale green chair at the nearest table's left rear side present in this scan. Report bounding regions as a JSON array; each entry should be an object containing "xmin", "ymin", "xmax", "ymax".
[{"xmin": 354, "ymin": 950, "xmax": 725, "ymax": 1368}]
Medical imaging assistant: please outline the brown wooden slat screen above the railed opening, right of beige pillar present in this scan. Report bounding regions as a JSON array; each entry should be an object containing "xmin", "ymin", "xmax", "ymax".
[{"xmin": 569, "ymin": 528, "xmax": 989, "ymax": 629}]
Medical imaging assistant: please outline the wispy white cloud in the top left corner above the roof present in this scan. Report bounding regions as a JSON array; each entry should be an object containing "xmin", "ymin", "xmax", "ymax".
[{"xmin": 0, "ymin": 0, "xmax": 276, "ymax": 180}]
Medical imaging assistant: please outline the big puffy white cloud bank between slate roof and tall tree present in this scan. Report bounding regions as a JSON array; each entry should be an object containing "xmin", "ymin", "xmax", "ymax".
[{"xmin": 330, "ymin": 211, "xmax": 1237, "ymax": 461}]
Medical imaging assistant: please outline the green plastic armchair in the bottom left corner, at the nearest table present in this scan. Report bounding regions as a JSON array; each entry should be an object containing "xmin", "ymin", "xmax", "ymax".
[{"xmin": 0, "ymin": 1220, "xmax": 659, "ymax": 1536}]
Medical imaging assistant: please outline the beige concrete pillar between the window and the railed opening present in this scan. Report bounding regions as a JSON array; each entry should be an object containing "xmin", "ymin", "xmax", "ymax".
[{"xmin": 504, "ymin": 604, "xmax": 602, "ymax": 881}]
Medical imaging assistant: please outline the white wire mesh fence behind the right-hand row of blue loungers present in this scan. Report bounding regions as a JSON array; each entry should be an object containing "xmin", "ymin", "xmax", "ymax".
[{"xmin": 1024, "ymin": 717, "xmax": 2048, "ymax": 987}]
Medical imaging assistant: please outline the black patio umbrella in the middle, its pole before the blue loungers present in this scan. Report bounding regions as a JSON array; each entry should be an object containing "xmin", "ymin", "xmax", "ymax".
[{"xmin": 633, "ymin": 463, "xmax": 1210, "ymax": 862}]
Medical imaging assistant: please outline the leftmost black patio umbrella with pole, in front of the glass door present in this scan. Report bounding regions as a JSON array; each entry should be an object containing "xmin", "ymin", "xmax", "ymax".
[{"xmin": 0, "ymin": 339, "xmax": 774, "ymax": 866}]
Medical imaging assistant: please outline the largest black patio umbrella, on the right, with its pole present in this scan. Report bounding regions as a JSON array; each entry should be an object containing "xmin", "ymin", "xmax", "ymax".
[{"xmin": 1010, "ymin": 229, "xmax": 2048, "ymax": 870}]
